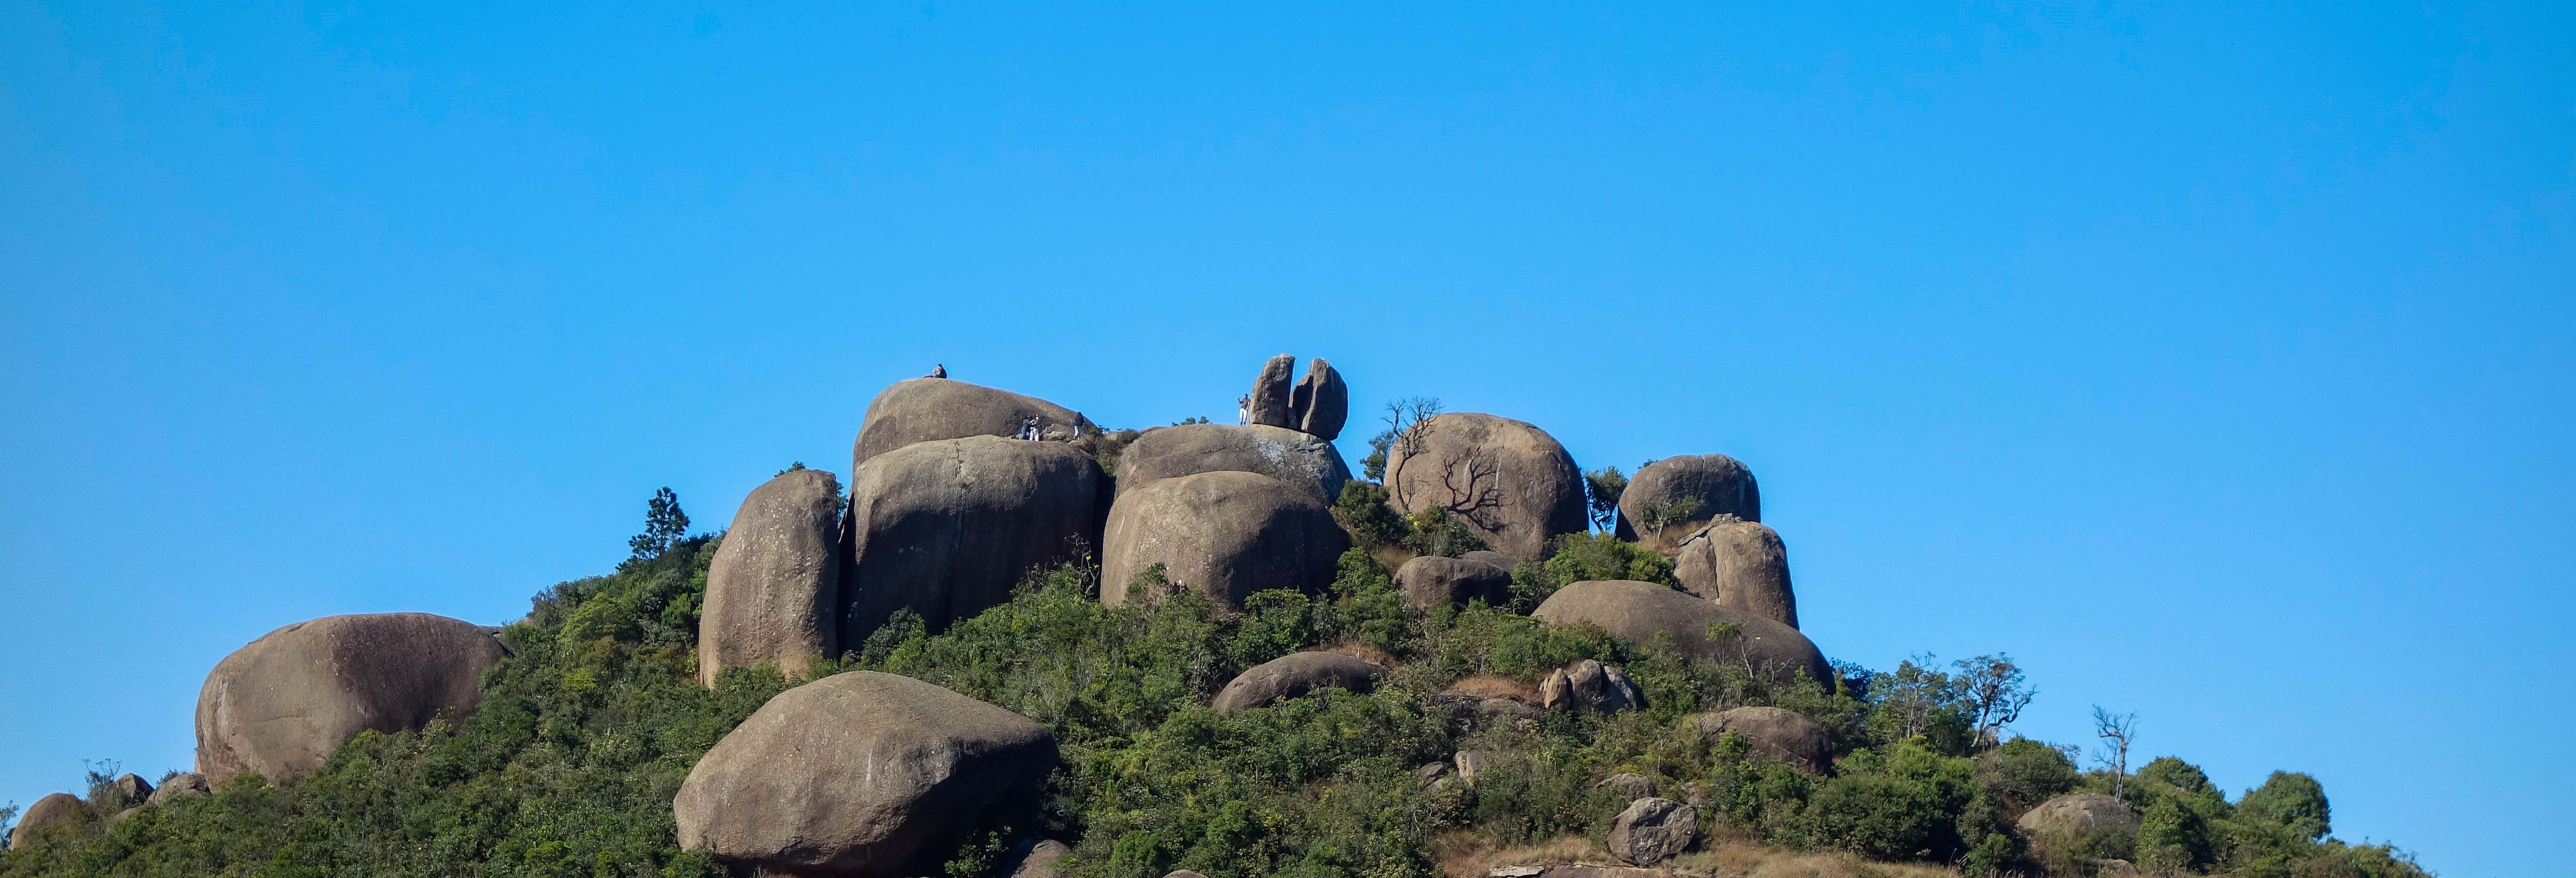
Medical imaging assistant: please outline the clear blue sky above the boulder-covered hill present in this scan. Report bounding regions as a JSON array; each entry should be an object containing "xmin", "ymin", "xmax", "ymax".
[{"xmin": 0, "ymin": 0, "xmax": 2576, "ymax": 876}]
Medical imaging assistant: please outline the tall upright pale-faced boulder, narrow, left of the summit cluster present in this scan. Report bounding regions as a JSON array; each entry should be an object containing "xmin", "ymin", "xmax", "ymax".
[{"xmin": 698, "ymin": 468, "xmax": 842, "ymax": 685}]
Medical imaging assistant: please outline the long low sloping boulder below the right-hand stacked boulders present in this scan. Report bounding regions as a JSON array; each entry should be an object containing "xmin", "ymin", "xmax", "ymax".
[{"xmin": 1530, "ymin": 580, "xmax": 1834, "ymax": 685}]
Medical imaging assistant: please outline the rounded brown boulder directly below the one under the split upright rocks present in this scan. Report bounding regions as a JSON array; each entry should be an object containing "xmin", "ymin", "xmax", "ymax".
[{"xmin": 1100, "ymin": 471, "xmax": 1350, "ymax": 608}]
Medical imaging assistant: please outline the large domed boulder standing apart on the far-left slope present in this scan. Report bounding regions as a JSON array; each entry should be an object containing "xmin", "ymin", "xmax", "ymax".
[{"xmin": 196, "ymin": 613, "xmax": 502, "ymax": 783}]
